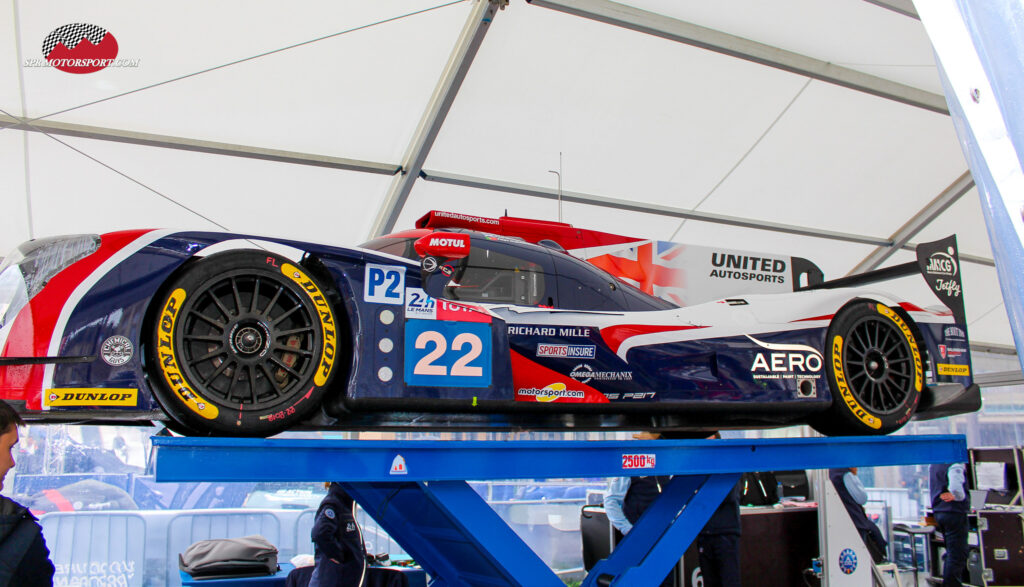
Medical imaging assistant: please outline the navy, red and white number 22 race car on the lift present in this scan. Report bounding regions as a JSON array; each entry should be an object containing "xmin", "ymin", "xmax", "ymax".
[{"xmin": 0, "ymin": 212, "xmax": 980, "ymax": 435}]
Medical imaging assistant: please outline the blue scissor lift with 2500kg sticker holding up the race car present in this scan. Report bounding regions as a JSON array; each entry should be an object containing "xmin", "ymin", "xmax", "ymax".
[{"xmin": 153, "ymin": 435, "xmax": 968, "ymax": 587}]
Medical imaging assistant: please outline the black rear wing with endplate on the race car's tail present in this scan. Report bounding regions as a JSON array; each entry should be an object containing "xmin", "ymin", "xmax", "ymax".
[{"xmin": 800, "ymin": 235, "xmax": 967, "ymax": 324}]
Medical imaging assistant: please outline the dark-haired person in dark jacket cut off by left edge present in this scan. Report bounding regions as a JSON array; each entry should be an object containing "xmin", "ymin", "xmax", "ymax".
[{"xmin": 0, "ymin": 401, "xmax": 54, "ymax": 587}]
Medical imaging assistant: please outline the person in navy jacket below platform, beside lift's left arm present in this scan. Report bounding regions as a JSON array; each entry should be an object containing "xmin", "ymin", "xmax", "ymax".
[{"xmin": 309, "ymin": 483, "xmax": 367, "ymax": 587}]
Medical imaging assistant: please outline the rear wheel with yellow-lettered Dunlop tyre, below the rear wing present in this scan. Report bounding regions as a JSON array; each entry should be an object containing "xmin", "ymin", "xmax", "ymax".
[{"xmin": 811, "ymin": 300, "xmax": 925, "ymax": 435}]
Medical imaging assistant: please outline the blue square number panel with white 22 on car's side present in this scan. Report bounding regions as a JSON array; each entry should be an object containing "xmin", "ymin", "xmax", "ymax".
[{"xmin": 404, "ymin": 320, "xmax": 492, "ymax": 387}]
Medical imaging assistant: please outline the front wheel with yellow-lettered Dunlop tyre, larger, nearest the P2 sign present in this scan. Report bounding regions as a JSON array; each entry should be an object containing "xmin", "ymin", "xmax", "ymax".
[{"xmin": 148, "ymin": 251, "xmax": 339, "ymax": 436}]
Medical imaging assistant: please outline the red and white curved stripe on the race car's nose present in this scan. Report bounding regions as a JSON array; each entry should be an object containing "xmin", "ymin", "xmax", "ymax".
[{"xmin": 0, "ymin": 230, "xmax": 172, "ymax": 410}]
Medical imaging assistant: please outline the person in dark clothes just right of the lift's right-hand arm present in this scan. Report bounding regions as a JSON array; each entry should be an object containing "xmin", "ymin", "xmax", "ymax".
[{"xmin": 697, "ymin": 432, "xmax": 741, "ymax": 587}]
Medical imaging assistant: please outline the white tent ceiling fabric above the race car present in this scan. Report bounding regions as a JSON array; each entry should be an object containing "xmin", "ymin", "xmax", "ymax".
[{"xmin": 0, "ymin": 0, "xmax": 1012, "ymax": 344}]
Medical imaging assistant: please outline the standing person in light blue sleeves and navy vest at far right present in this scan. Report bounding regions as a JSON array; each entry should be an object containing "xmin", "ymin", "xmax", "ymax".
[{"xmin": 928, "ymin": 463, "xmax": 971, "ymax": 587}]
